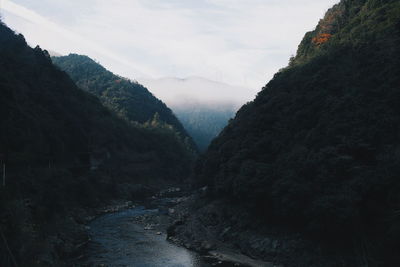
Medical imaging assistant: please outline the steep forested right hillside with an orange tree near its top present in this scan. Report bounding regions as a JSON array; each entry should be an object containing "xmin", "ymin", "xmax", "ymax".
[{"xmin": 196, "ymin": 0, "xmax": 400, "ymax": 266}]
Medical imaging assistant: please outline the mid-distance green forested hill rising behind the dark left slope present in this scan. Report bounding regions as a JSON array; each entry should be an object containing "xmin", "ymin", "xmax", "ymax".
[{"xmin": 52, "ymin": 54, "xmax": 196, "ymax": 150}]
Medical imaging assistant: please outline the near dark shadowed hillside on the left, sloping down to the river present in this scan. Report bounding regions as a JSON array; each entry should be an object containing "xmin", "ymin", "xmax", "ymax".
[{"xmin": 0, "ymin": 23, "xmax": 193, "ymax": 266}]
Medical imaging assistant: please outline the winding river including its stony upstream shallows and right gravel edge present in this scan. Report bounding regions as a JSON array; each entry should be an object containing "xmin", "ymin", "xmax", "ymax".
[{"xmin": 73, "ymin": 188, "xmax": 274, "ymax": 267}]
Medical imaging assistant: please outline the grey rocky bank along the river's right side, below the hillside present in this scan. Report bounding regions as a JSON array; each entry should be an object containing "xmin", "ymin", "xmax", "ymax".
[{"xmin": 163, "ymin": 191, "xmax": 361, "ymax": 267}]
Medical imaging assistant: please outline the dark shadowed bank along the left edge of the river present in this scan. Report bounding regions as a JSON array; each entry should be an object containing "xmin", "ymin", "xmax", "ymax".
[{"xmin": 27, "ymin": 184, "xmax": 160, "ymax": 267}]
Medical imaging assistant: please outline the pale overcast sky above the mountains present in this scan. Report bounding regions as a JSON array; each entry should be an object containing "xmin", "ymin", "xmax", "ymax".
[{"xmin": 0, "ymin": 0, "xmax": 338, "ymax": 89}]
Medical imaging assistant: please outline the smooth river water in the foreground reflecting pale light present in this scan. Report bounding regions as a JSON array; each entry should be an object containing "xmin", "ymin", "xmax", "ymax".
[{"xmin": 84, "ymin": 207, "xmax": 202, "ymax": 267}]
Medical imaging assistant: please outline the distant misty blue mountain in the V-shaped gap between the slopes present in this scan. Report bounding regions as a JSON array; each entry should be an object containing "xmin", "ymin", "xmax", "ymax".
[{"xmin": 139, "ymin": 77, "xmax": 255, "ymax": 151}]
